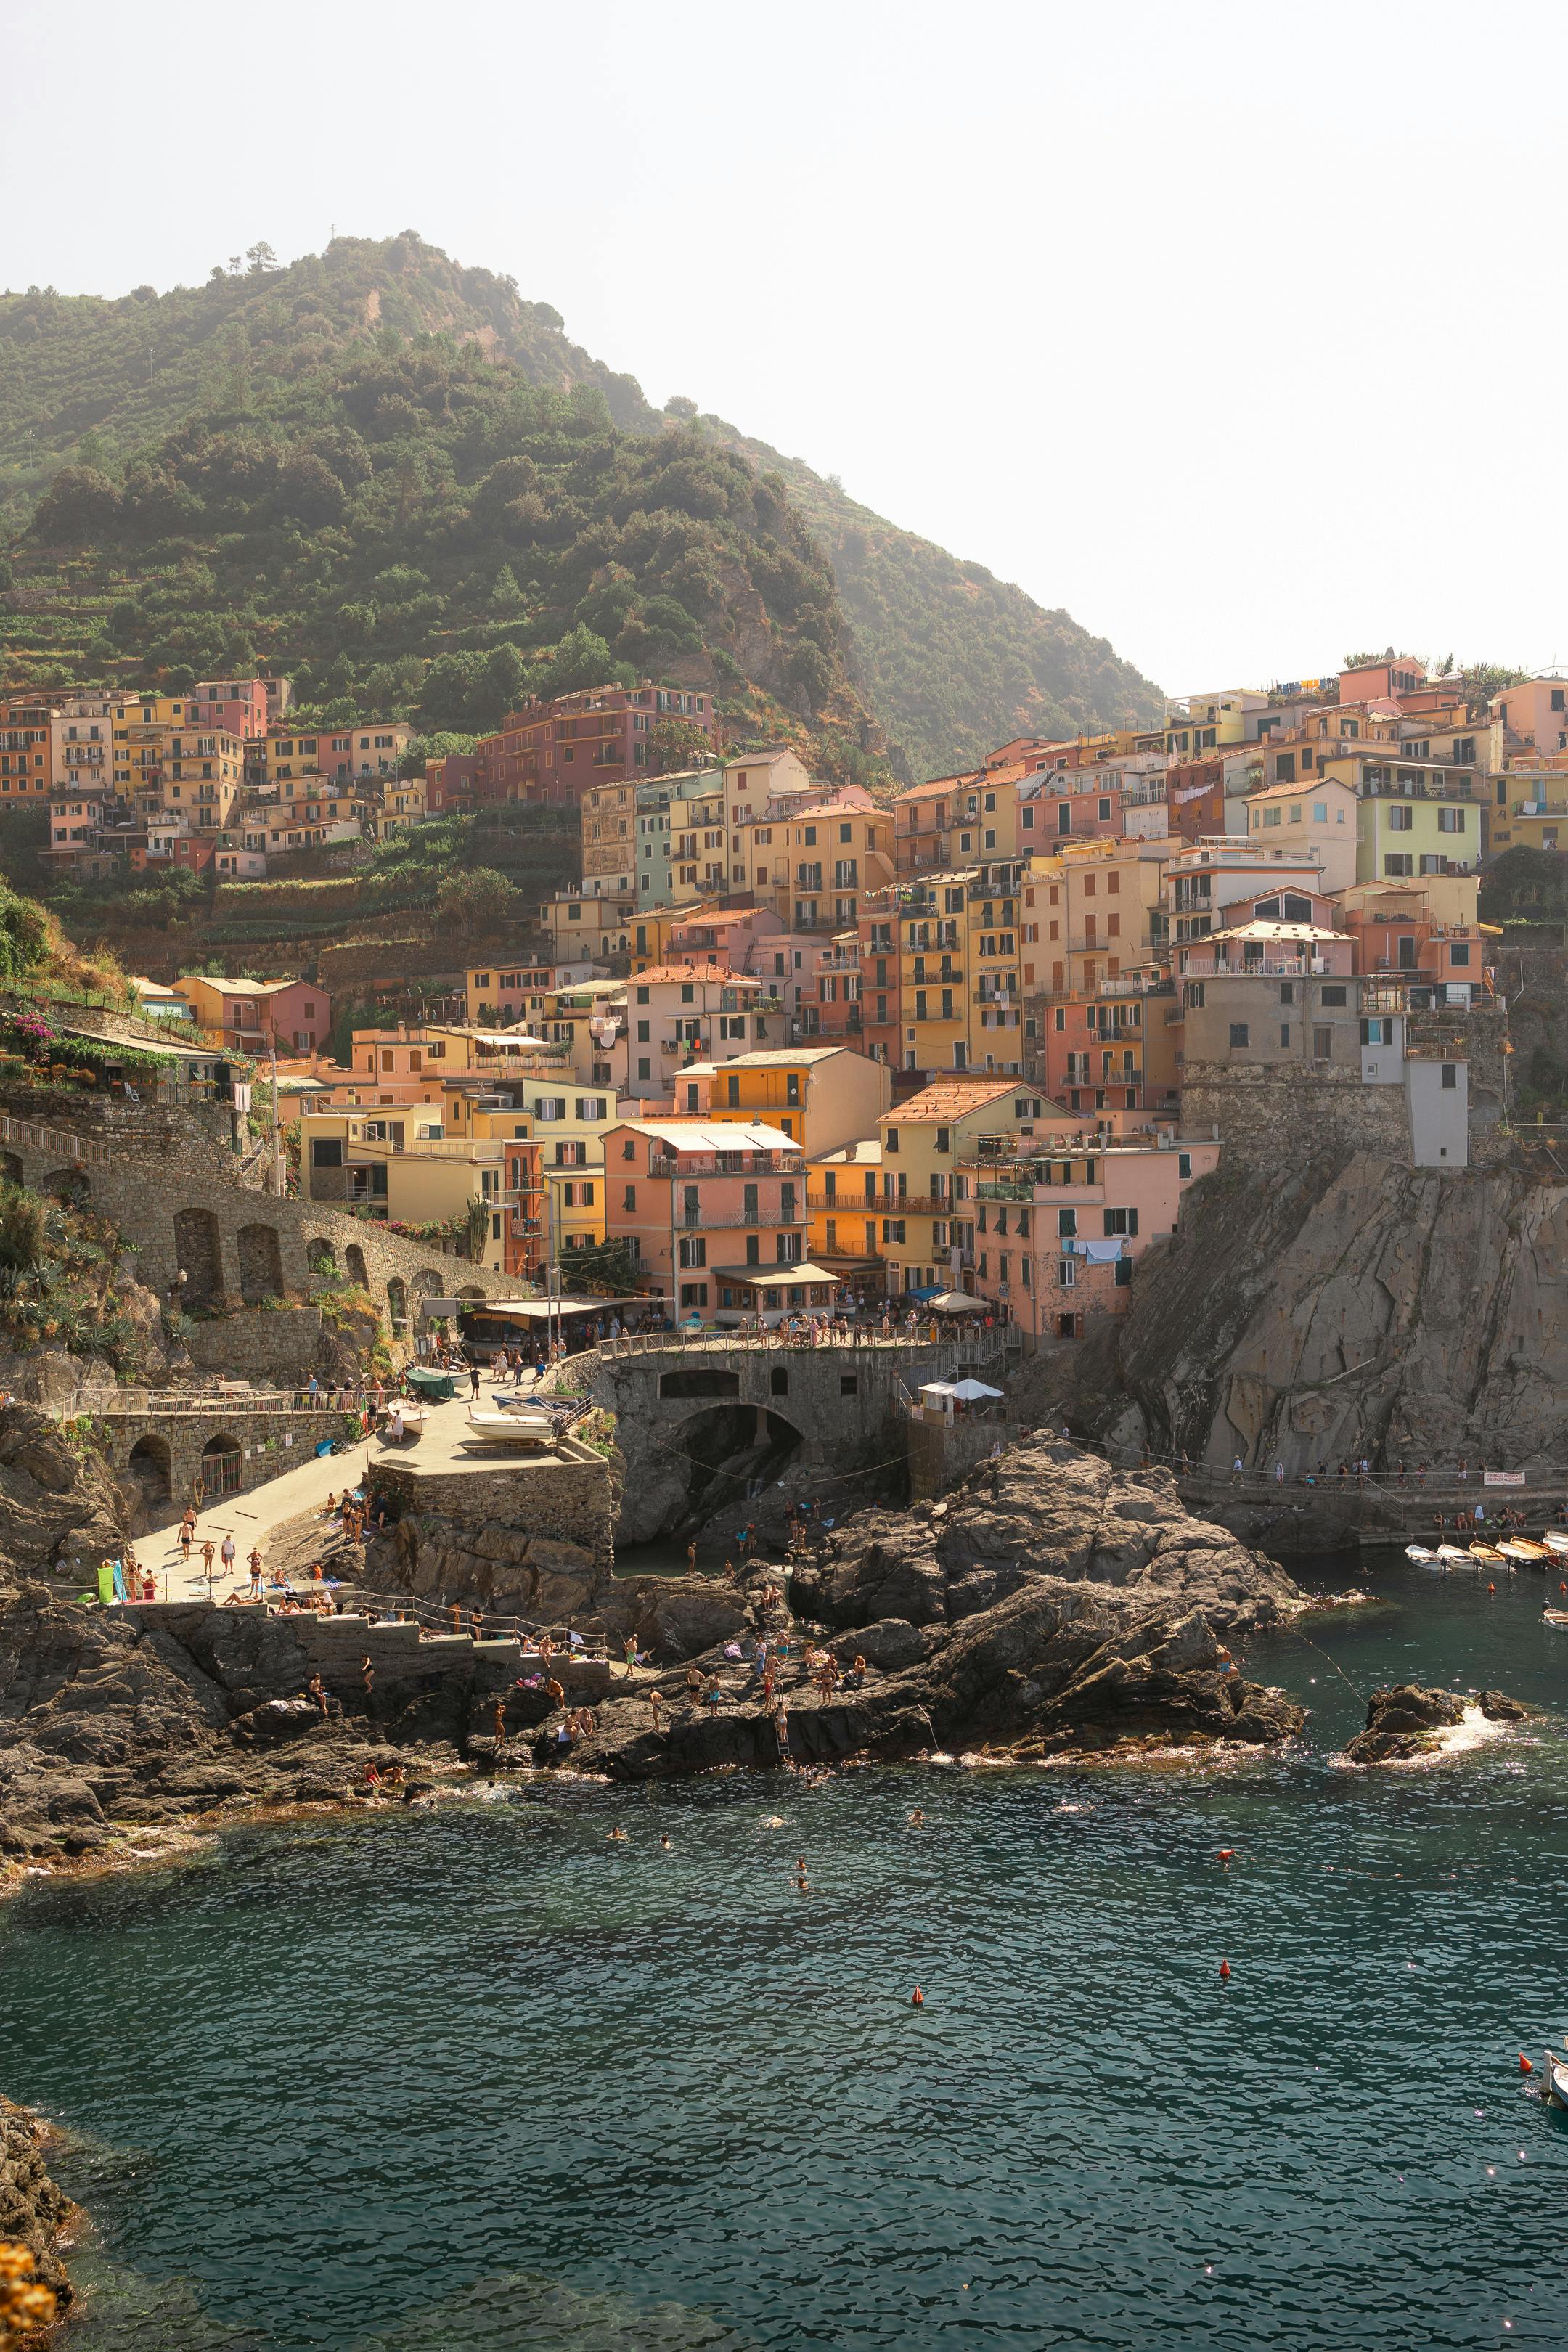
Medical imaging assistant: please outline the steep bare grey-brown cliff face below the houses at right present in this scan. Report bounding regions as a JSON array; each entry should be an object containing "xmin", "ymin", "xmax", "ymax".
[{"xmin": 1044, "ymin": 1153, "xmax": 1568, "ymax": 1470}]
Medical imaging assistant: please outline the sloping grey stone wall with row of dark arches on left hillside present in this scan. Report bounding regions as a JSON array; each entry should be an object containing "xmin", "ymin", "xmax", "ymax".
[{"xmin": 0, "ymin": 1115, "xmax": 505, "ymax": 1339}]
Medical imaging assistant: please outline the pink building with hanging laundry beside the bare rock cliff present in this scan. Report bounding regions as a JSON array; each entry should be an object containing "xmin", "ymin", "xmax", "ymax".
[{"xmin": 959, "ymin": 1136, "xmax": 1220, "ymax": 1341}]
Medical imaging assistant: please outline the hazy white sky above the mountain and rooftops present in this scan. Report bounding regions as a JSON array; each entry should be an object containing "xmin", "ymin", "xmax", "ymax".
[{"xmin": 0, "ymin": 0, "xmax": 1568, "ymax": 692}]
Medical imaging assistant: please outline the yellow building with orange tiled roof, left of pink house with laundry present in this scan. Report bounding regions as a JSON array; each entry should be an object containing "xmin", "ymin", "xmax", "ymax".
[{"xmin": 870, "ymin": 1077, "xmax": 1053, "ymax": 1298}]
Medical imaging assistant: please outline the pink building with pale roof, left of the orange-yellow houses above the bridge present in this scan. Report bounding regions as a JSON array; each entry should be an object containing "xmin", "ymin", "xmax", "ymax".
[{"xmin": 604, "ymin": 1119, "xmax": 809, "ymax": 1320}]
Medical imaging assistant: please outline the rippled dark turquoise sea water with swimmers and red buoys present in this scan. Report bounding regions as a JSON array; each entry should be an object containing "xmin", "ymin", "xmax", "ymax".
[{"xmin": 0, "ymin": 1561, "xmax": 1568, "ymax": 2352}]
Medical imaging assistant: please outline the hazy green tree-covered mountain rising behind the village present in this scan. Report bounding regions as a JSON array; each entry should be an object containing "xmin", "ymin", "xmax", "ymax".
[{"xmin": 0, "ymin": 231, "xmax": 1159, "ymax": 776}]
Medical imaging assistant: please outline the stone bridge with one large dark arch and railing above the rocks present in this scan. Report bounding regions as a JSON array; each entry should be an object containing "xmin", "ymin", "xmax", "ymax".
[{"xmin": 548, "ymin": 1336, "xmax": 995, "ymax": 1548}]
